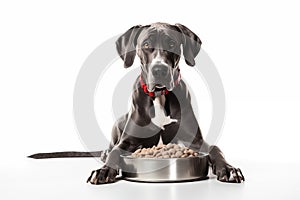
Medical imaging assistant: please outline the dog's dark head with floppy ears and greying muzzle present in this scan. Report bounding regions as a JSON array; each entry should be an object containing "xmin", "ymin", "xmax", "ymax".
[{"xmin": 116, "ymin": 23, "xmax": 201, "ymax": 92}]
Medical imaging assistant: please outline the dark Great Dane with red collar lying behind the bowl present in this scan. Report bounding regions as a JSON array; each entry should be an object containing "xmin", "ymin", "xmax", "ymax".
[{"xmin": 30, "ymin": 23, "xmax": 245, "ymax": 184}]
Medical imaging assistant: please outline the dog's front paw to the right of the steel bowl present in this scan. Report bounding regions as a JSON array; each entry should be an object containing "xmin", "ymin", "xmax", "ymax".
[{"xmin": 213, "ymin": 163, "xmax": 245, "ymax": 183}]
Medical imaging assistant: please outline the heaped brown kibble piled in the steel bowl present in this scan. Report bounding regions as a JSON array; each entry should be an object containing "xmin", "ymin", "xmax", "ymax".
[{"xmin": 131, "ymin": 143, "xmax": 199, "ymax": 158}]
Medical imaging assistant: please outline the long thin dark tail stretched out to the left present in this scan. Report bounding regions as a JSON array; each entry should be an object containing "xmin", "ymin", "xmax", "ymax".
[{"xmin": 28, "ymin": 150, "xmax": 109, "ymax": 162}]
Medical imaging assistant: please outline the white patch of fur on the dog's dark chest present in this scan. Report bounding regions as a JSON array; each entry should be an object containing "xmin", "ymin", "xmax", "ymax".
[{"xmin": 151, "ymin": 95, "xmax": 177, "ymax": 130}]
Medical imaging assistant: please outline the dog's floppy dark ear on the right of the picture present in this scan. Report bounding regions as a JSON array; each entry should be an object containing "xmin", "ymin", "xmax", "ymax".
[{"xmin": 175, "ymin": 24, "xmax": 202, "ymax": 66}]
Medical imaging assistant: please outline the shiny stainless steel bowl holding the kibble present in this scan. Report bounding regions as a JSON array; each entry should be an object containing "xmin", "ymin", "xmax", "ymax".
[{"xmin": 121, "ymin": 153, "xmax": 208, "ymax": 182}]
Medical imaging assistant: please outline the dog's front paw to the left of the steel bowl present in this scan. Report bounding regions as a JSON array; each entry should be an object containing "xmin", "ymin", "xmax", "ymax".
[{"xmin": 87, "ymin": 165, "xmax": 118, "ymax": 185}]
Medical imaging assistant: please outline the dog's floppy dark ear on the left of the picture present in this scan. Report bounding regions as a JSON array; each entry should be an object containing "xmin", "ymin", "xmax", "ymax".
[{"xmin": 116, "ymin": 25, "xmax": 141, "ymax": 68}]
